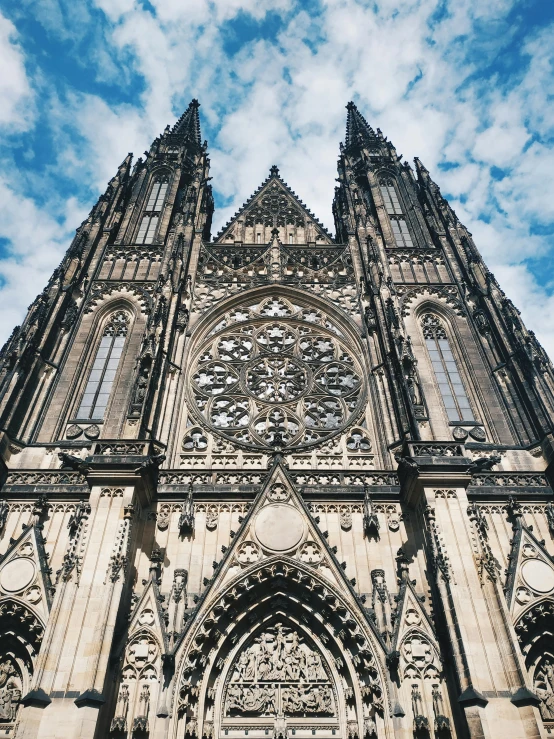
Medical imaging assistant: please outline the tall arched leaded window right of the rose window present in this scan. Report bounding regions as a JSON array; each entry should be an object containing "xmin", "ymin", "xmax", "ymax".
[{"xmin": 421, "ymin": 313, "xmax": 475, "ymax": 421}]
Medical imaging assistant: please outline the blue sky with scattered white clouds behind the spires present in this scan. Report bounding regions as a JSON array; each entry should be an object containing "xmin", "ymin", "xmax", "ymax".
[{"xmin": 0, "ymin": 0, "xmax": 554, "ymax": 355}]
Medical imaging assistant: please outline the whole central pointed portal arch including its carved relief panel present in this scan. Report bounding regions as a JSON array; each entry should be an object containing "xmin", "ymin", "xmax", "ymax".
[{"xmin": 171, "ymin": 555, "xmax": 390, "ymax": 739}]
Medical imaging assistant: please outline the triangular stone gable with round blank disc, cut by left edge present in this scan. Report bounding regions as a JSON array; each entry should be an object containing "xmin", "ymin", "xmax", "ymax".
[{"xmin": 0, "ymin": 526, "xmax": 53, "ymax": 623}]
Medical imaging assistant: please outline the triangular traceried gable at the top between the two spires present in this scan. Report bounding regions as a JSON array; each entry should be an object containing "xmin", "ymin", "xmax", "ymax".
[{"xmin": 214, "ymin": 166, "xmax": 334, "ymax": 245}]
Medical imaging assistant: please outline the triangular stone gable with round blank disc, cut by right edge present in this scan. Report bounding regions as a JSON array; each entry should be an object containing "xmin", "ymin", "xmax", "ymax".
[{"xmin": 504, "ymin": 519, "xmax": 554, "ymax": 622}]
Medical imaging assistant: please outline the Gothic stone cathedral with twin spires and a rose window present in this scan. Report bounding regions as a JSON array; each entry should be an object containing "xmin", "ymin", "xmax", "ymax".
[{"xmin": 0, "ymin": 100, "xmax": 554, "ymax": 739}]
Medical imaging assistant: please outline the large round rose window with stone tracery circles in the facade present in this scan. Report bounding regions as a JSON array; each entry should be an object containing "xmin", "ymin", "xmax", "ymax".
[{"xmin": 188, "ymin": 297, "xmax": 364, "ymax": 448}]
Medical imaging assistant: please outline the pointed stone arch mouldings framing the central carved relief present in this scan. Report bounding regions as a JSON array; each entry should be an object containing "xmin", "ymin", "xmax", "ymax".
[{"xmin": 173, "ymin": 556, "xmax": 389, "ymax": 738}]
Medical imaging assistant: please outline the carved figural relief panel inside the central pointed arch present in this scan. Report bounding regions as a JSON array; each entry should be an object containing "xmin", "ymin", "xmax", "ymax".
[{"xmin": 224, "ymin": 623, "xmax": 336, "ymax": 717}]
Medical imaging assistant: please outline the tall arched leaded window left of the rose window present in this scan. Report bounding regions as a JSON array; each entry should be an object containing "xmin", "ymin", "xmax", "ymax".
[{"xmin": 77, "ymin": 310, "xmax": 129, "ymax": 421}]
